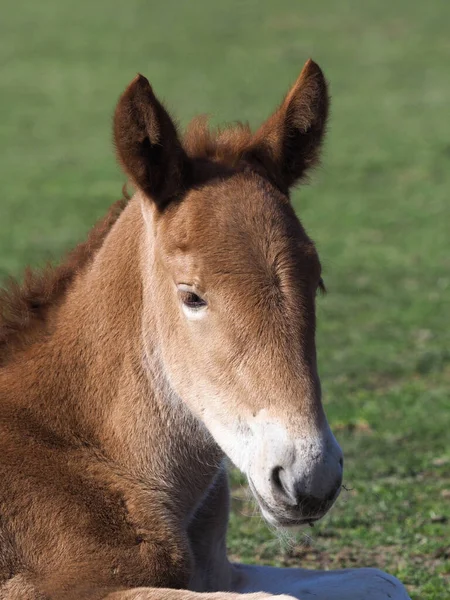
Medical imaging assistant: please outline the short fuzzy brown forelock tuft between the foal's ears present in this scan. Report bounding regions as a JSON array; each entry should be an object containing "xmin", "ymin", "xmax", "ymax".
[{"xmin": 183, "ymin": 115, "xmax": 252, "ymax": 166}]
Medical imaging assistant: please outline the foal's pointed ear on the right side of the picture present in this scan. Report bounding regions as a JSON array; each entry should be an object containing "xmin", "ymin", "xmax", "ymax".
[{"xmin": 249, "ymin": 59, "xmax": 329, "ymax": 192}]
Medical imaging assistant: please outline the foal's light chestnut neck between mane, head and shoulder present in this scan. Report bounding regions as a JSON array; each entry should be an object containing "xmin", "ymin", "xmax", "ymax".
[{"xmin": 18, "ymin": 198, "xmax": 222, "ymax": 518}]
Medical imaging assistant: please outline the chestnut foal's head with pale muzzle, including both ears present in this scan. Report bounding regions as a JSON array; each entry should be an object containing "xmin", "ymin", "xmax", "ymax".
[{"xmin": 114, "ymin": 61, "xmax": 342, "ymax": 525}]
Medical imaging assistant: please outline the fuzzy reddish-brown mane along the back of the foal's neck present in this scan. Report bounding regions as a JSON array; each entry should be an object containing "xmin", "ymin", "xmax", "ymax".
[{"xmin": 0, "ymin": 194, "xmax": 128, "ymax": 365}]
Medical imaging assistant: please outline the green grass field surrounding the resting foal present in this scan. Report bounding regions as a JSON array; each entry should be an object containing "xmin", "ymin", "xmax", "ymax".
[{"xmin": 0, "ymin": 0, "xmax": 450, "ymax": 600}]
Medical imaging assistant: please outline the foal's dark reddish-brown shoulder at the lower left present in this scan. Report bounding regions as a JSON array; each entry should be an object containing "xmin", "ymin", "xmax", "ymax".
[{"xmin": 0, "ymin": 431, "xmax": 190, "ymax": 598}]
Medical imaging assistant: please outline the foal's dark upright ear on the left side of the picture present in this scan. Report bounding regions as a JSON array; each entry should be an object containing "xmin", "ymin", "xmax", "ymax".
[{"xmin": 114, "ymin": 75, "xmax": 187, "ymax": 208}]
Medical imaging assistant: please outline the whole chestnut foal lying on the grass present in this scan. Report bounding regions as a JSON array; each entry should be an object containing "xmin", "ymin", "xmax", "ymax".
[{"xmin": 0, "ymin": 61, "xmax": 407, "ymax": 600}]
